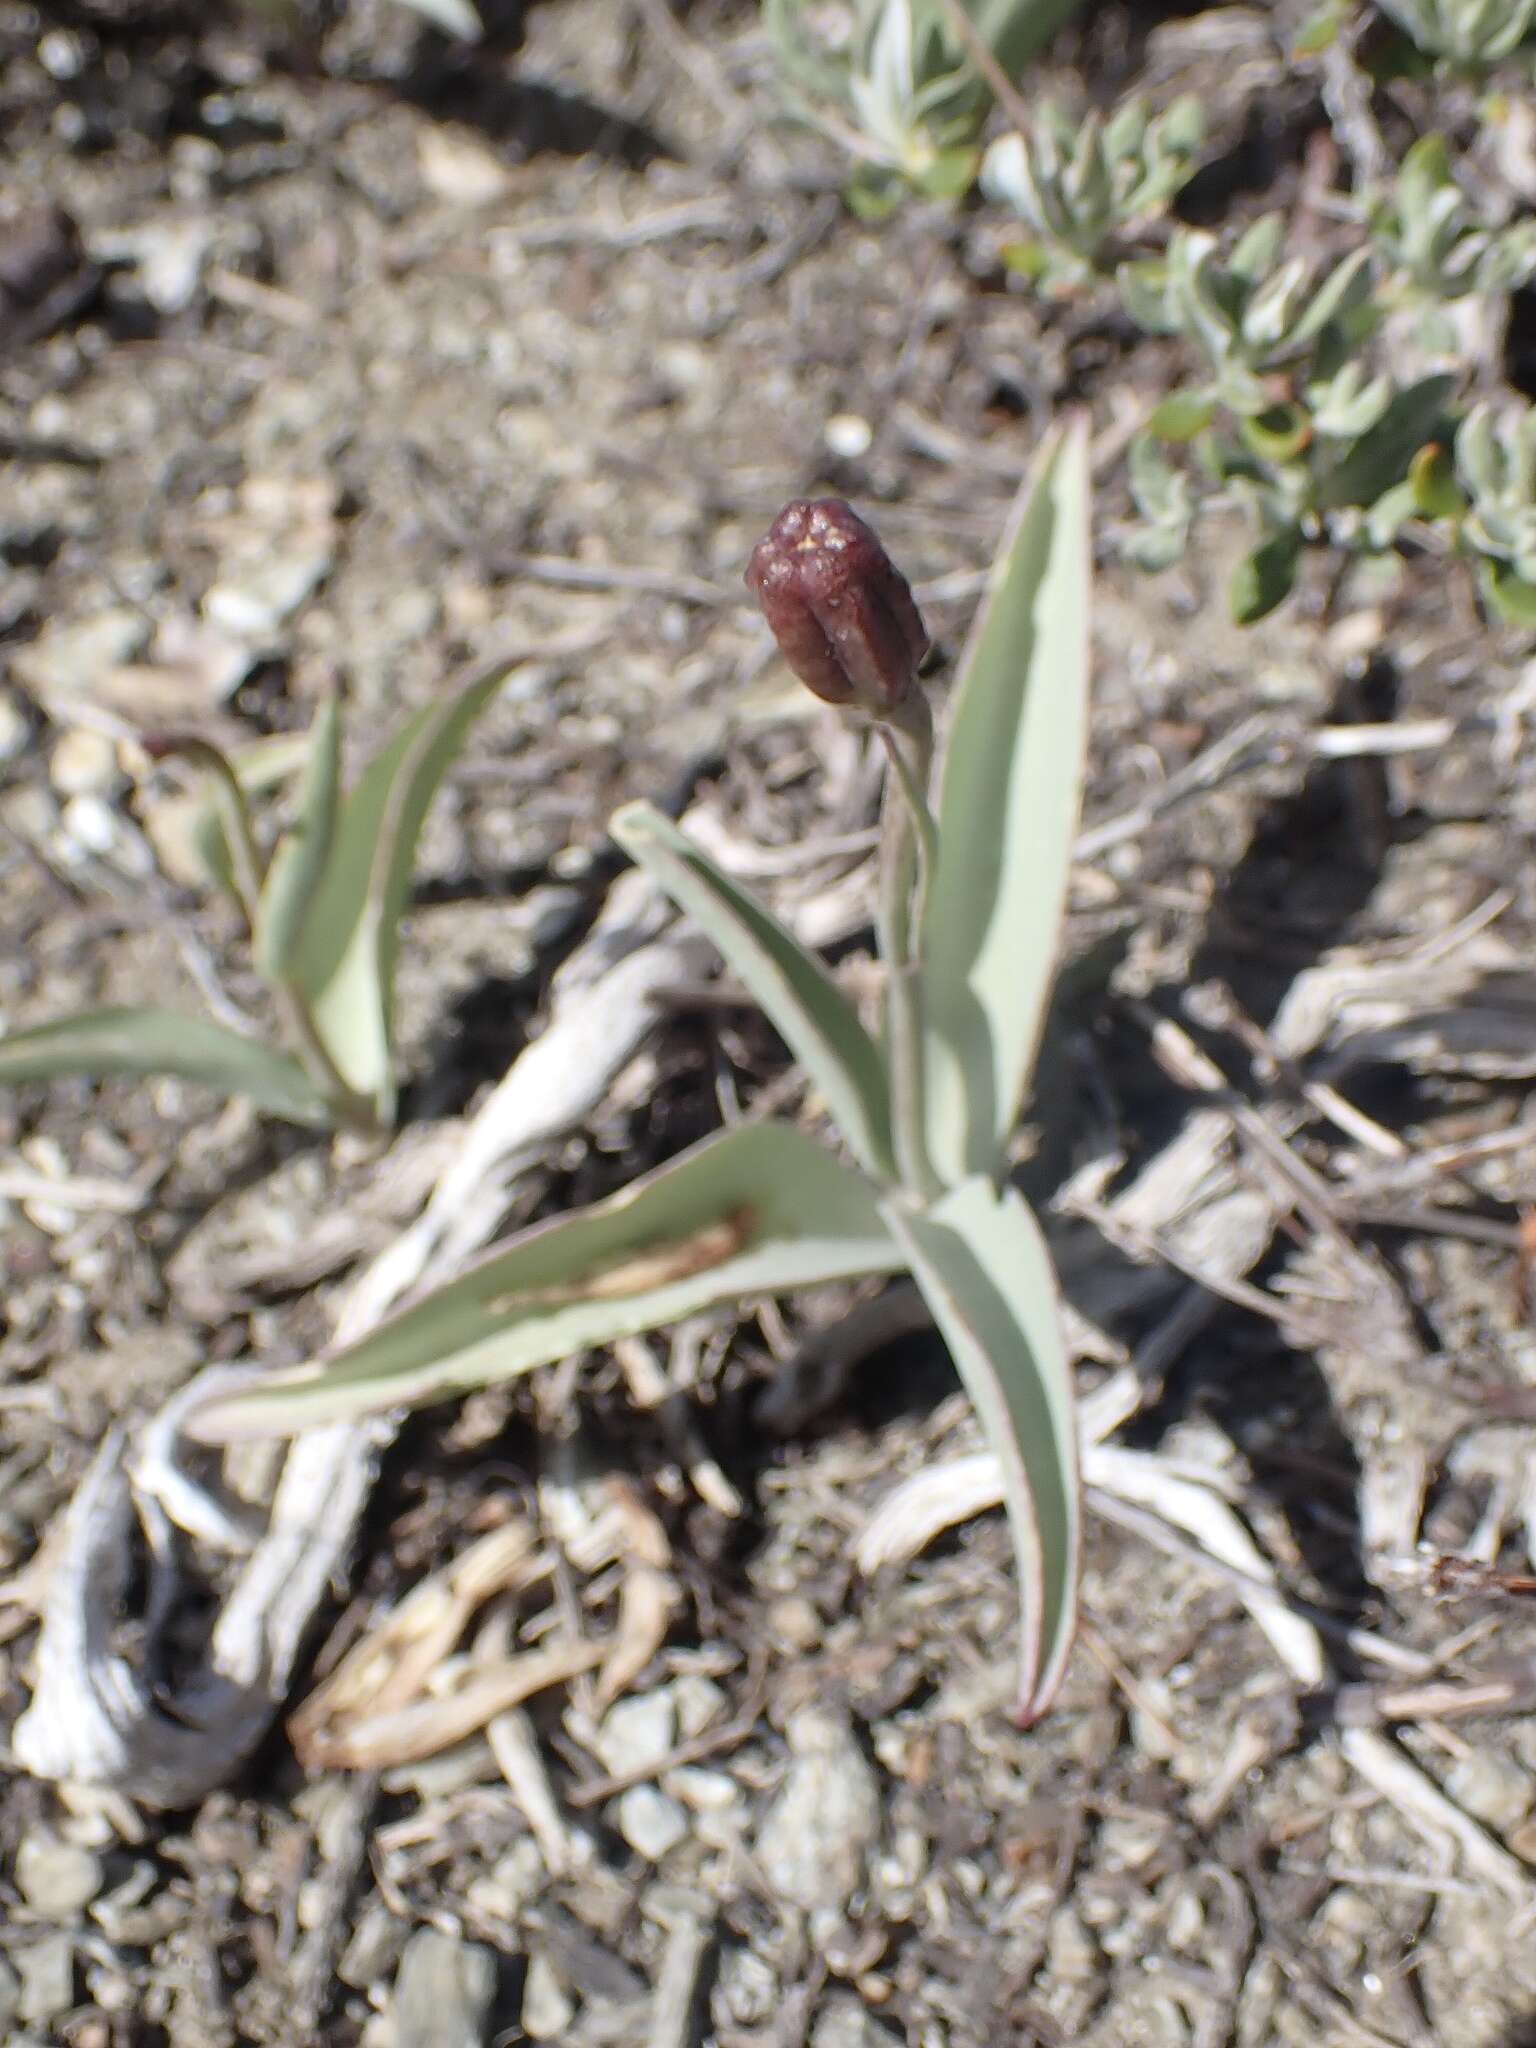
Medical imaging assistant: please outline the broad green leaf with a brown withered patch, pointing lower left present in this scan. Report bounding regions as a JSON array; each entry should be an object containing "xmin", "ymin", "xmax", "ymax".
[{"xmin": 190, "ymin": 1124, "xmax": 905, "ymax": 1442}]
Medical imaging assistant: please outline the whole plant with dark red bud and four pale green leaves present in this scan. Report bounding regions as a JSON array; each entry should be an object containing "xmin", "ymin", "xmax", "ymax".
[{"xmin": 201, "ymin": 436, "xmax": 1092, "ymax": 1722}]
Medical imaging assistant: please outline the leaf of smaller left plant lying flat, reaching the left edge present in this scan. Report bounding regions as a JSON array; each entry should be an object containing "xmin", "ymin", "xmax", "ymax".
[{"xmin": 0, "ymin": 1008, "xmax": 332, "ymax": 1126}]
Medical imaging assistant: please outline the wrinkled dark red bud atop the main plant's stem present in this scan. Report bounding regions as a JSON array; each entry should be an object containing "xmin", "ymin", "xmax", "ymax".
[{"xmin": 745, "ymin": 498, "xmax": 928, "ymax": 719}]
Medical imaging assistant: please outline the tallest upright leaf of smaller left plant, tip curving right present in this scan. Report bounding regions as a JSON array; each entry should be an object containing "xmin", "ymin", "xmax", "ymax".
[{"xmin": 289, "ymin": 662, "xmax": 516, "ymax": 1122}]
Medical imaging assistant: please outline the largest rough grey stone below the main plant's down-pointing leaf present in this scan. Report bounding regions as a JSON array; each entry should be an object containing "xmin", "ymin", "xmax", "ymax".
[{"xmin": 758, "ymin": 1706, "xmax": 881, "ymax": 1913}]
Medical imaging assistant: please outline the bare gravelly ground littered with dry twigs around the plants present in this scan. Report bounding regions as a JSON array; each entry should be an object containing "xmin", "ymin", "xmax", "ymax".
[{"xmin": 0, "ymin": 0, "xmax": 1536, "ymax": 2048}]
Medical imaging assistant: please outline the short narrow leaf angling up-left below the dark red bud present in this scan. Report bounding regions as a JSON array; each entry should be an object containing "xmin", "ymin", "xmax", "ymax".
[{"xmin": 608, "ymin": 803, "xmax": 895, "ymax": 1180}]
